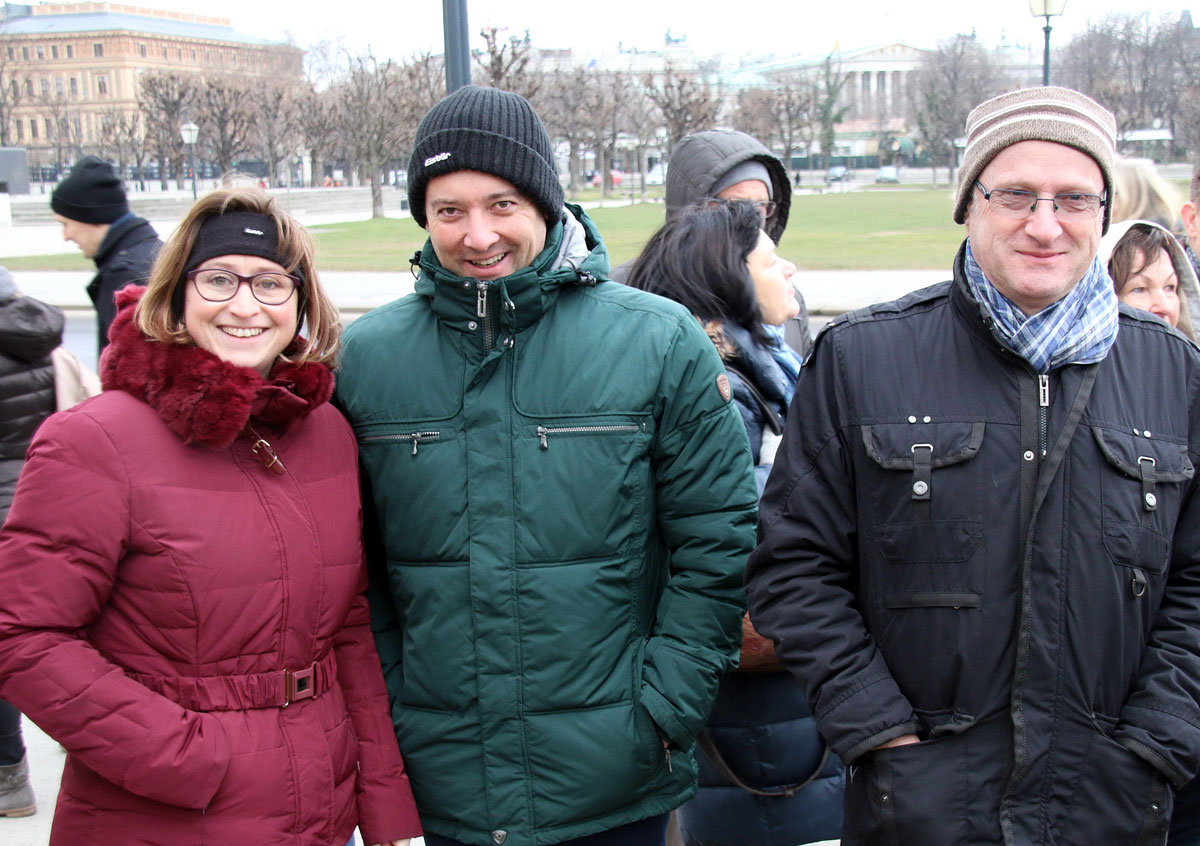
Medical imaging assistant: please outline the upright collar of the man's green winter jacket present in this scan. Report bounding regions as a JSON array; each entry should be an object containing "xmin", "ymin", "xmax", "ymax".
[{"xmin": 415, "ymin": 203, "xmax": 608, "ymax": 332}]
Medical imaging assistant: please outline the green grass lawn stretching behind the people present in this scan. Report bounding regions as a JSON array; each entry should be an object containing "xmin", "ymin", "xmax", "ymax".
[{"xmin": 2, "ymin": 186, "xmax": 965, "ymax": 271}]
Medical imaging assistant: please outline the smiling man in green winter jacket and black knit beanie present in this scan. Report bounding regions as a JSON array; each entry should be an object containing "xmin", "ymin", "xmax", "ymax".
[{"xmin": 337, "ymin": 86, "xmax": 755, "ymax": 846}]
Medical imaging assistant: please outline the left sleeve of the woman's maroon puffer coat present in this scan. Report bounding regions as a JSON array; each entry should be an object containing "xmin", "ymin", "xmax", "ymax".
[{"xmin": 0, "ymin": 406, "xmax": 229, "ymax": 809}]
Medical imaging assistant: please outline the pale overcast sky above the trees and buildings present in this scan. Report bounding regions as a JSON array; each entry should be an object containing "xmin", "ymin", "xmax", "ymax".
[{"xmin": 145, "ymin": 0, "xmax": 1200, "ymax": 59}]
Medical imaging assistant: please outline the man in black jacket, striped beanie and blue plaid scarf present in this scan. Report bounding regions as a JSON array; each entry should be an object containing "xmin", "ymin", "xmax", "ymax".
[{"xmin": 746, "ymin": 88, "xmax": 1200, "ymax": 846}]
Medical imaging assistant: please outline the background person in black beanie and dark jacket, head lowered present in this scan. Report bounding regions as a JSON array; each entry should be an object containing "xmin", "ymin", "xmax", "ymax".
[{"xmin": 50, "ymin": 156, "xmax": 162, "ymax": 352}]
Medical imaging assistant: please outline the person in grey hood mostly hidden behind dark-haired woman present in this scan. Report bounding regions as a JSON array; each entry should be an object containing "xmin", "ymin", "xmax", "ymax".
[{"xmin": 612, "ymin": 130, "xmax": 812, "ymax": 359}]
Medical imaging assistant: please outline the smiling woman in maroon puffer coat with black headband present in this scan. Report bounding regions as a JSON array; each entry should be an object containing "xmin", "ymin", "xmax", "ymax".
[{"xmin": 0, "ymin": 190, "xmax": 420, "ymax": 846}]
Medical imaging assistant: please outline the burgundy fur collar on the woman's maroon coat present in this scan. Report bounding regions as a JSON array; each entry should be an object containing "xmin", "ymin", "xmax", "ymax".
[{"xmin": 100, "ymin": 286, "xmax": 334, "ymax": 449}]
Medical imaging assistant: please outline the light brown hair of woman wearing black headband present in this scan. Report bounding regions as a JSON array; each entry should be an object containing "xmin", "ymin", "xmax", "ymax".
[{"xmin": 133, "ymin": 187, "xmax": 342, "ymax": 366}]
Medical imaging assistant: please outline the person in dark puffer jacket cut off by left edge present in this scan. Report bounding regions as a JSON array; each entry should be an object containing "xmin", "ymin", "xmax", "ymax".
[{"xmin": 0, "ymin": 268, "xmax": 62, "ymax": 817}]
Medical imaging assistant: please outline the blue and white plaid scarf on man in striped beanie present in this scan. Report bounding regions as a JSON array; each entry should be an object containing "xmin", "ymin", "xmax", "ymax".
[{"xmin": 964, "ymin": 239, "xmax": 1117, "ymax": 373}]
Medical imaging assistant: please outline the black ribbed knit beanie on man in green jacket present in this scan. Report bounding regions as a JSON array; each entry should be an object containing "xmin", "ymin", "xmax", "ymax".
[{"xmin": 408, "ymin": 85, "xmax": 563, "ymax": 227}]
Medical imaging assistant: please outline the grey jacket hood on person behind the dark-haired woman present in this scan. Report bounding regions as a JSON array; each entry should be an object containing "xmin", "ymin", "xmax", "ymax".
[{"xmin": 666, "ymin": 130, "xmax": 792, "ymax": 244}]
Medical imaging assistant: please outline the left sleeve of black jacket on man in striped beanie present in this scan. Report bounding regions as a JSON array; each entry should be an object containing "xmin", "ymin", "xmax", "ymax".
[{"xmin": 746, "ymin": 326, "xmax": 918, "ymax": 763}]
